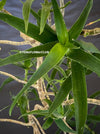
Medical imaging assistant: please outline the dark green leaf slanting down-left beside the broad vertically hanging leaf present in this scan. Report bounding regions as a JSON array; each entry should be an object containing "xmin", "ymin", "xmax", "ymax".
[{"xmin": 49, "ymin": 76, "xmax": 72, "ymax": 114}]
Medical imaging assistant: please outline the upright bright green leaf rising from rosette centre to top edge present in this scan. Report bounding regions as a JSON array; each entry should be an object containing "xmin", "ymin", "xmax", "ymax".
[{"xmin": 52, "ymin": 0, "xmax": 69, "ymax": 45}]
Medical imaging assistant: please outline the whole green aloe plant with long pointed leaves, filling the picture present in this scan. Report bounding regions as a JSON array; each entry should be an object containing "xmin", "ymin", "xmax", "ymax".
[{"xmin": 0, "ymin": 0, "xmax": 100, "ymax": 134}]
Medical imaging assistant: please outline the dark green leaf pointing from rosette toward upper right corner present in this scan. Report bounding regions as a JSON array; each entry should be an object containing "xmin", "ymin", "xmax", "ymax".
[{"xmin": 69, "ymin": 0, "xmax": 93, "ymax": 41}]
